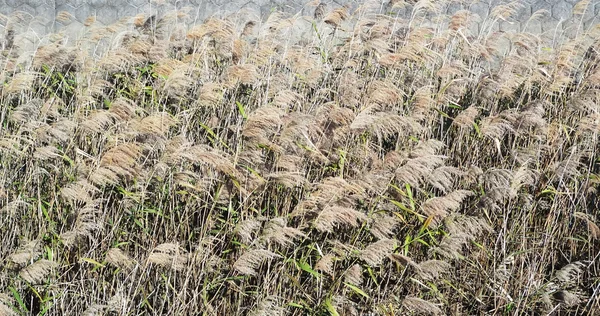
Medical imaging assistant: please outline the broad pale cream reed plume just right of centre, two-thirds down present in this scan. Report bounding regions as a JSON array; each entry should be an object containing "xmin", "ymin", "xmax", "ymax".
[{"xmin": 313, "ymin": 206, "xmax": 367, "ymax": 233}]
